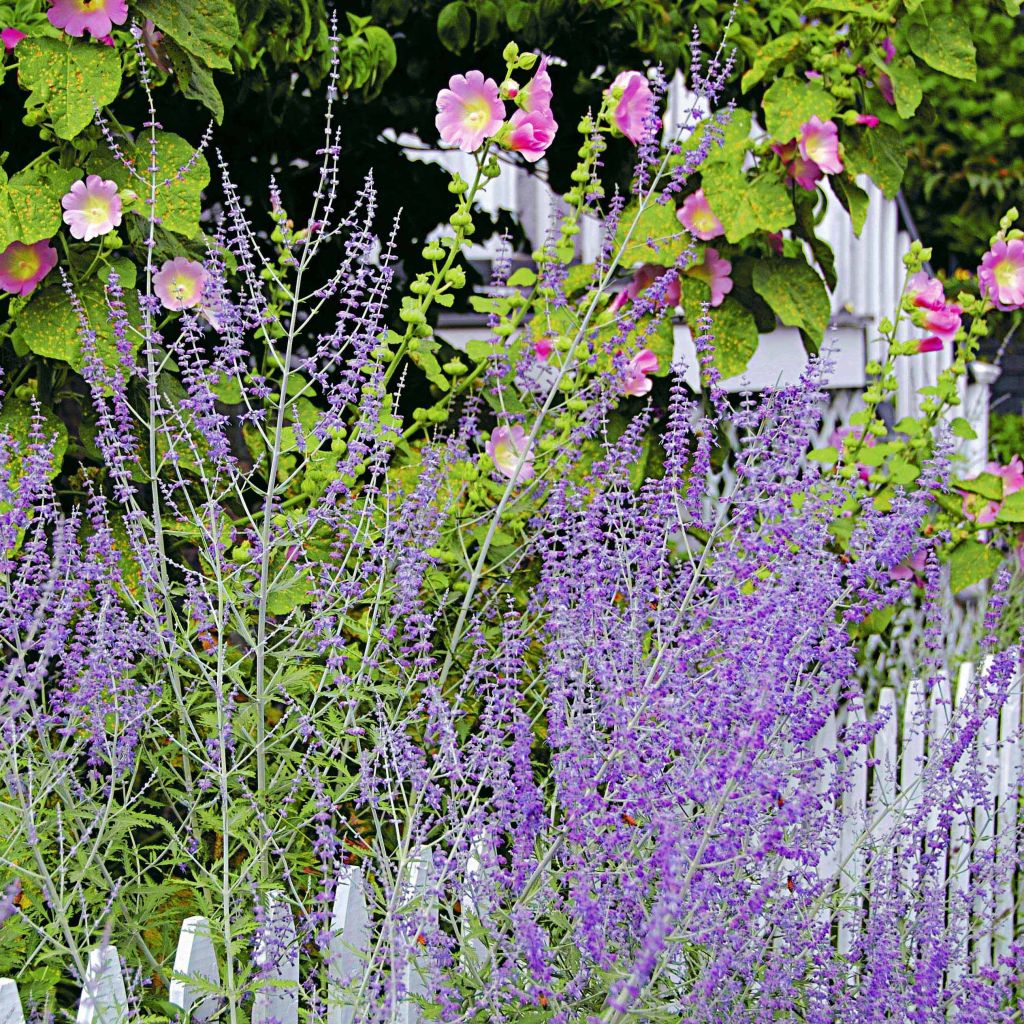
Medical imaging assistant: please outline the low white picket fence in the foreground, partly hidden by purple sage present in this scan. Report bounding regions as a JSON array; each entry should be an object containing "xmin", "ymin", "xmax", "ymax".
[{"xmin": 0, "ymin": 656, "xmax": 1024, "ymax": 1024}]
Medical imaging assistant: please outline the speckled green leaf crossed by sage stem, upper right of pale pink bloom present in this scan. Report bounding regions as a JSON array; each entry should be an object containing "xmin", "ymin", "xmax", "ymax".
[{"xmin": 89, "ymin": 131, "xmax": 210, "ymax": 238}]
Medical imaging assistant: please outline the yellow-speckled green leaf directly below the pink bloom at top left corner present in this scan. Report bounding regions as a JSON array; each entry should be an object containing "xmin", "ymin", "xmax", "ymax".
[{"xmin": 17, "ymin": 36, "xmax": 121, "ymax": 139}]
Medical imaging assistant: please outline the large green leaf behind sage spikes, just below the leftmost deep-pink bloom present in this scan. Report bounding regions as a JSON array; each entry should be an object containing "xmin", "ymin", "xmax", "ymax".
[{"xmin": 11, "ymin": 281, "xmax": 140, "ymax": 373}]
